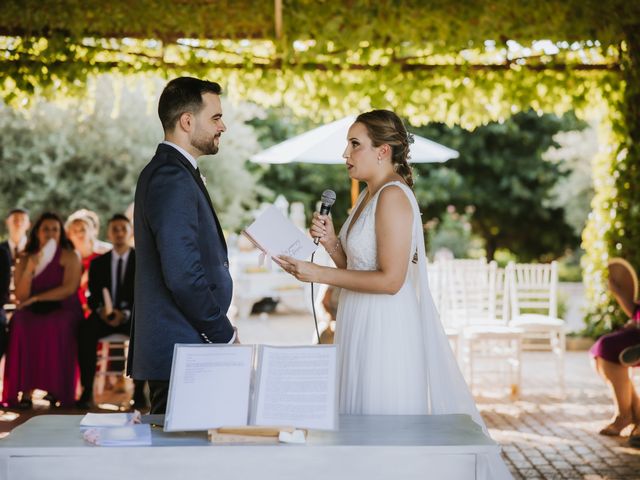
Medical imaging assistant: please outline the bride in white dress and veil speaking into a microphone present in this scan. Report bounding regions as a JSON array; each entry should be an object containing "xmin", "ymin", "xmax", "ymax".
[{"xmin": 276, "ymin": 110, "xmax": 511, "ymax": 479}]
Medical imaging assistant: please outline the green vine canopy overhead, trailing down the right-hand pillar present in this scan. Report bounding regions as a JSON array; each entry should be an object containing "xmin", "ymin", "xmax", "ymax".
[{"xmin": 0, "ymin": 0, "xmax": 640, "ymax": 338}]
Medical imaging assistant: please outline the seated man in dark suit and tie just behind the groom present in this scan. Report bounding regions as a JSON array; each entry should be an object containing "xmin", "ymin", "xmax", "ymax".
[{"xmin": 76, "ymin": 214, "xmax": 146, "ymax": 409}]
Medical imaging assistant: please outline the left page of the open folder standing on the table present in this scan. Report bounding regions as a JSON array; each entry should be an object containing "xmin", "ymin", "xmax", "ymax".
[{"xmin": 164, "ymin": 344, "xmax": 253, "ymax": 432}]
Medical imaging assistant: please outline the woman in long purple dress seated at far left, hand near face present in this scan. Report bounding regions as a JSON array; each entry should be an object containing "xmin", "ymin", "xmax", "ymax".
[{"xmin": 2, "ymin": 213, "xmax": 82, "ymax": 408}]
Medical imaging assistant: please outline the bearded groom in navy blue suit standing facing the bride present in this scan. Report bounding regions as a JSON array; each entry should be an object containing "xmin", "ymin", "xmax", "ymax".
[{"xmin": 128, "ymin": 77, "xmax": 237, "ymax": 413}]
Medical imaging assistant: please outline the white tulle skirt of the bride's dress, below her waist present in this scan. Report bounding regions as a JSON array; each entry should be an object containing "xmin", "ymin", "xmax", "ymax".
[{"xmin": 335, "ymin": 282, "xmax": 428, "ymax": 415}]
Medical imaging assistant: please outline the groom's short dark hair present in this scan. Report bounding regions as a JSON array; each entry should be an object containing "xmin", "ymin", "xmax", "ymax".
[{"xmin": 158, "ymin": 77, "xmax": 222, "ymax": 132}]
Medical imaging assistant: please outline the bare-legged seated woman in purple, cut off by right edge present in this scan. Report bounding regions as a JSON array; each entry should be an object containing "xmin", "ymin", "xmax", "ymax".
[{"xmin": 590, "ymin": 275, "xmax": 640, "ymax": 438}]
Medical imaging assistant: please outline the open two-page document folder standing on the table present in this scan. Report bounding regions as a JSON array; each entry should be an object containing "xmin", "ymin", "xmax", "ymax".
[{"xmin": 164, "ymin": 344, "xmax": 338, "ymax": 432}]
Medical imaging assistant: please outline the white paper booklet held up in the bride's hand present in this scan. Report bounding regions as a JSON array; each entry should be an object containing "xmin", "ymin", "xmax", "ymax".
[{"xmin": 242, "ymin": 205, "xmax": 318, "ymax": 260}]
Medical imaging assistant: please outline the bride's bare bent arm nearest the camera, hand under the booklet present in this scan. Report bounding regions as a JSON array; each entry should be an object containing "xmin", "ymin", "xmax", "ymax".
[{"xmin": 281, "ymin": 186, "xmax": 413, "ymax": 294}]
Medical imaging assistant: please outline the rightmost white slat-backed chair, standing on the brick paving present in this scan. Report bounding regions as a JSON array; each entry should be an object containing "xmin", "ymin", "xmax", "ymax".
[{"xmin": 507, "ymin": 262, "xmax": 566, "ymax": 394}]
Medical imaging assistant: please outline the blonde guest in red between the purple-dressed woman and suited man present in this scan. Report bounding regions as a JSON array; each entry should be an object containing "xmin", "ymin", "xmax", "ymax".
[{"xmin": 64, "ymin": 208, "xmax": 111, "ymax": 317}]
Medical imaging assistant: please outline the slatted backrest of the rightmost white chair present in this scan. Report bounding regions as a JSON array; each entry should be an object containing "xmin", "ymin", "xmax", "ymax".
[{"xmin": 507, "ymin": 261, "xmax": 558, "ymax": 318}]
